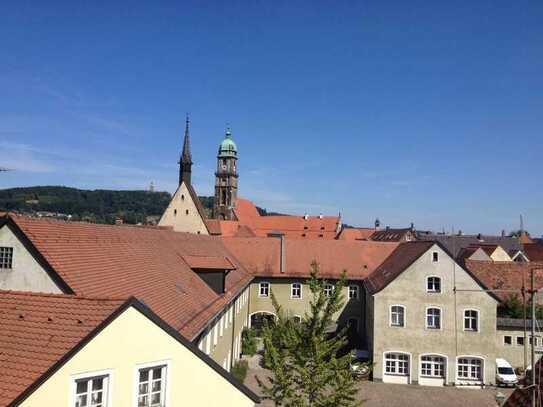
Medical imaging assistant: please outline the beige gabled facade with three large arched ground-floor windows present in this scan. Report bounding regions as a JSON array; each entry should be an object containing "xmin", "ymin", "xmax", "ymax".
[{"xmin": 367, "ymin": 244, "xmax": 497, "ymax": 386}]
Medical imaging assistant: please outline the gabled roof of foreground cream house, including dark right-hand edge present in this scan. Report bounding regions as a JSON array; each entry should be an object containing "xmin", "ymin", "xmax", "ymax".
[{"xmin": 0, "ymin": 291, "xmax": 259, "ymax": 407}]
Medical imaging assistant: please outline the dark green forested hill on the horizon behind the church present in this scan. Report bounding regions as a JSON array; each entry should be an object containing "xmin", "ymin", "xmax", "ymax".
[{"xmin": 0, "ymin": 186, "xmax": 213, "ymax": 223}]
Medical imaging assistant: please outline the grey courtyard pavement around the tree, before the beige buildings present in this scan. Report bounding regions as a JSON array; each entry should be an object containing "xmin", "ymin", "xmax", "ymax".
[{"xmin": 245, "ymin": 355, "xmax": 512, "ymax": 407}]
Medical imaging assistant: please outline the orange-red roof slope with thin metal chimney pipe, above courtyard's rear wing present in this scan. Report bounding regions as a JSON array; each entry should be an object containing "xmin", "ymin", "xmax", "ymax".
[{"xmin": 223, "ymin": 238, "xmax": 398, "ymax": 280}]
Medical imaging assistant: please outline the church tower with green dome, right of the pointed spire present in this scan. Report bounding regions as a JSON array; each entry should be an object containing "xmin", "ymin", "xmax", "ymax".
[{"xmin": 213, "ymin": 128, "xmax": 238, "ymax": 220}]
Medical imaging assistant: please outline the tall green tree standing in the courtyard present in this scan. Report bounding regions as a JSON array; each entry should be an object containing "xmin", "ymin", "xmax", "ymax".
[{"xmin": 257, "ymin": 262, "xmax": 361, "ymax": 407}]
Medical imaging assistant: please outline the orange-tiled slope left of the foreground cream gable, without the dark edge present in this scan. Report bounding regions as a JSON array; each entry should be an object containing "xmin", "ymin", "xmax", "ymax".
[{"xmin": 0, "ymin": 291, "xmax": 126, "ymax": 407}]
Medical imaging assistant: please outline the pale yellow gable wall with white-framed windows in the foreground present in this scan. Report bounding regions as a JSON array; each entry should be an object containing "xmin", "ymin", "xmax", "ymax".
[{"xmin": 19, "ymin": 308, "xmax": 255, "ymax": 407}]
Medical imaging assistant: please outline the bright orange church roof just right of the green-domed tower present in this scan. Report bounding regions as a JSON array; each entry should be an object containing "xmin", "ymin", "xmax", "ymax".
[{"xmin": 233, "ymin": 198, "xmax": 341, "ymax": 239}]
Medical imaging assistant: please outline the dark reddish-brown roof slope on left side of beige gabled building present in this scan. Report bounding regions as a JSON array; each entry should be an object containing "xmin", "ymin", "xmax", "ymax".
[{"xmin": 365, "ymin": 242, "xmax": 435, "ymax": 294}]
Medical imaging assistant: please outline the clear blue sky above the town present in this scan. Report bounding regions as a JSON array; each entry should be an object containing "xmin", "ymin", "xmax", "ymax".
[{"xmin": 0, "ymin": 0, "xmax": 543, "ymax": 235}]
